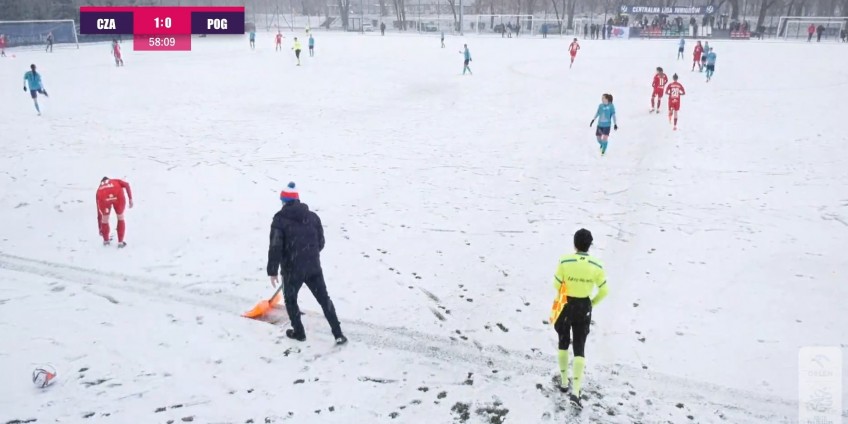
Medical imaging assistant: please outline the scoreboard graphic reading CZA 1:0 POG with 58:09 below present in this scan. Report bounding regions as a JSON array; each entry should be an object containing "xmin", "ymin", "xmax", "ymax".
[{"xmin": 80, "ymin": 6, "xmax": 244, "ymax": 51}]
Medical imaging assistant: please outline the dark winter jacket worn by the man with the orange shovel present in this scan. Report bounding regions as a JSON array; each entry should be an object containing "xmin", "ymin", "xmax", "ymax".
[{"xmin": 268, "ymin": 200, "xmax": 324, "ymax": 277}]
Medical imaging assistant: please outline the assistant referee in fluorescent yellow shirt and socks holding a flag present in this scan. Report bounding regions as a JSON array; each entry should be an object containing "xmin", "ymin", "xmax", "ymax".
[{"xmin": 550, "ymin": 228, "xmax": 609, "ymax": 407}]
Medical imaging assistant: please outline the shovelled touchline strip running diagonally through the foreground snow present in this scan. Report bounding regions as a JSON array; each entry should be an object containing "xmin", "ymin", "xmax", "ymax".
[{"xmin": 0, "ymin": 252, "xmax": 797, "ymax": 422}]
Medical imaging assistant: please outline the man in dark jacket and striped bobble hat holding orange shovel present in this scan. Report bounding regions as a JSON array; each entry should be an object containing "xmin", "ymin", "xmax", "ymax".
[{"xmin": 268, "ymin": 182, "xmax": 347, "ymax": 345}]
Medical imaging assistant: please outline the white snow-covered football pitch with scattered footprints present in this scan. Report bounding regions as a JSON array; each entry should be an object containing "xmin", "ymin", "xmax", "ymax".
[{"xmin": 0, "ymin": 33, "xmax": 848, "ymax": 424}]
